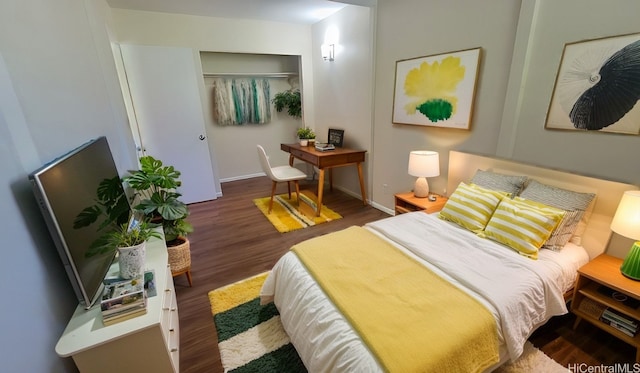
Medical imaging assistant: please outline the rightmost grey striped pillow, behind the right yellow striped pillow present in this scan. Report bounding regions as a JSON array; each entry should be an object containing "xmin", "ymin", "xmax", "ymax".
[{"xmin": 520, "ymin": 180, "xmax": 596, "ymax": 250}]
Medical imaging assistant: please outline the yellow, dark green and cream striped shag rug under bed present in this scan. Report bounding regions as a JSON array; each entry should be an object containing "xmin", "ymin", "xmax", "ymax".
[{"xmin": 209, "ymin": 272, "xmax": 569, "ymax": 373}]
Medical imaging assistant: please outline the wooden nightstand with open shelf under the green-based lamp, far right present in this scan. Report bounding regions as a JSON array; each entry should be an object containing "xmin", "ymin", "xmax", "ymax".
[{"xmin": 571, "ymin": 254, "xmax": 640, "ymax": 362}]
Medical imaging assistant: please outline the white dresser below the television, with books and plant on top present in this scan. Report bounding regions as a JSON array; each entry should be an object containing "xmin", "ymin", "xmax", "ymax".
[{"xmin": 56, "ymin": 239, "xmax": 180, "ymax": 373}]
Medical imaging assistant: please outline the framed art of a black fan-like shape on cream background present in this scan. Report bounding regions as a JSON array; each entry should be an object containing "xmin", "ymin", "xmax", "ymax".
[{"xmin": 545, "ymin": 34, "xmax": 640, "ymax": 135}]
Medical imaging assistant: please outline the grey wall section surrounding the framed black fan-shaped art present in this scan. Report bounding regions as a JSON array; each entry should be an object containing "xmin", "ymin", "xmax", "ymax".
[{"xmin": 500, "ymin": 0, "xmax": 640, "ymax": 185}]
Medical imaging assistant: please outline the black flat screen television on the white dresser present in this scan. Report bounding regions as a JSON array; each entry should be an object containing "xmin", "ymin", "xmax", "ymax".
[{"xmin": 29, "ymin": 137, "xmax": 129, "ymax": 309}]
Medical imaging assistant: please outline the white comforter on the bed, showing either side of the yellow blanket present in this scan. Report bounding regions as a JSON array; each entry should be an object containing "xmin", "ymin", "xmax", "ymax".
[{"xmin": 261, "ymin": 213, "xmax": 588, "ymax": 372}]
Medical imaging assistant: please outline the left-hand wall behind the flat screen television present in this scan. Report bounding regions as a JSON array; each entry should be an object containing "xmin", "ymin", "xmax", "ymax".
[{"xmin": 0, "ymin": 0, "xmax": 135, "ymax": 372}]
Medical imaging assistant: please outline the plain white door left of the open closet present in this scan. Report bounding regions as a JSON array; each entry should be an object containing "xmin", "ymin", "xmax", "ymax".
[{"xmin": 120, "ymin": 44, "xmax": 219, "ymax": 203}]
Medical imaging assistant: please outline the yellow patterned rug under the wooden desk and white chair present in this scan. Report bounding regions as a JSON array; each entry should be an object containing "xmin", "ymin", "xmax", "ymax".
[{"xmin": 253, "ymin": 193, "xmax": 342, "ymax": 233}]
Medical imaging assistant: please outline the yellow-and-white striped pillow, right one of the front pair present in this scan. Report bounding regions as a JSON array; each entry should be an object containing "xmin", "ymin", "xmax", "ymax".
[{"xmin": 478, "ymin": 197, "xmax": 565, "ymax": 259}]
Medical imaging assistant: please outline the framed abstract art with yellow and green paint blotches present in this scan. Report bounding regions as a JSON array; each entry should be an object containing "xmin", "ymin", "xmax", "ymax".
[{"xmin": 392, "ymin": 48, "xmax": 480, "ymax": 130}]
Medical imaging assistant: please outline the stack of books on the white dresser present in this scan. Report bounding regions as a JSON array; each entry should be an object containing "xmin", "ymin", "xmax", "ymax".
[{"xmin": 100, "ymin": 275, "xmax": 147, "ymax": 325}]
